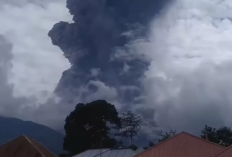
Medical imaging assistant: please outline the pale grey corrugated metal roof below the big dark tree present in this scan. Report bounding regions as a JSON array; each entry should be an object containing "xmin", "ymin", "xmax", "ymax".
[{"xmin": 73, "ymin": 148, "xmax": 136, "ymax": 157}]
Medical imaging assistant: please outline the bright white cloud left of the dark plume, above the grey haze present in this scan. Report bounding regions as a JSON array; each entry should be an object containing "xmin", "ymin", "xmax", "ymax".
[{"xmin": 0, "ymin": 0, "xmax": 71, "ymax": 101}]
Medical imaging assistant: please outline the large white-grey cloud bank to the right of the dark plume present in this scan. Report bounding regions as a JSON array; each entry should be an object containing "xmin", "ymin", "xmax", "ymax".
[{"xmin": 130, "ymin": 0, "xmax": 232, "ymax": 133}]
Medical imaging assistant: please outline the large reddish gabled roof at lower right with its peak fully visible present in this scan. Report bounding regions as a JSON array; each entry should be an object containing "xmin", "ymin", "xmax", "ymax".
[{"xmin": 135, "ymin": 132, "xmax": 226, "ymax": 157}]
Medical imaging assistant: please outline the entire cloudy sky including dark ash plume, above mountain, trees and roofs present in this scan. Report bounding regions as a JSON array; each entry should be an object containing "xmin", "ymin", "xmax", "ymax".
[{"xmin": 0, "ymin": 0, "xmax": 232, "ymax": 139}]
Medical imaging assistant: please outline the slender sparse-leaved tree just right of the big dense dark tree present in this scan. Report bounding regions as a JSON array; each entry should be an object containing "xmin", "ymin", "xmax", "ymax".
[{"xmin": 120, "ymin": 111, "xmax": 142, "ymax": 145}]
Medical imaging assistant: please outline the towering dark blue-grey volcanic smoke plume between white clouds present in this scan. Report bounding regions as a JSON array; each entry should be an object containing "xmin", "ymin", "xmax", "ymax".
[{"xmin": 48, "ymin": 0, "xmax": 171, "ymax": 109}]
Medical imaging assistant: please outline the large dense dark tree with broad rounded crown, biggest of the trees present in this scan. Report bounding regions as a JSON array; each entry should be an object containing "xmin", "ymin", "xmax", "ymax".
[{"xmin": 63, "ymin": 100, "xmax": 121, "ymax": 154}]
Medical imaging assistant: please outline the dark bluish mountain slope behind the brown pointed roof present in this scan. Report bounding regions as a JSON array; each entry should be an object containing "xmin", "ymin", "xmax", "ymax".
[{"xmin": 0, "ymin": 117, "xmax": 64, "ymax": 154}]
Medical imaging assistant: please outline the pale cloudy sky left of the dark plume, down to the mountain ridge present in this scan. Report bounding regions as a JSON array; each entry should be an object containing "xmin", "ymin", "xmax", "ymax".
[{"xmin": 0, "ymin": 0, "xmax": 72, "ymax": 127}]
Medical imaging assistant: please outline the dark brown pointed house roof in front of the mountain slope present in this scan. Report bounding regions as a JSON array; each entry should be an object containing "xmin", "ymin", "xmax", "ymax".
[{"xmin": 0, "ymin": 135, "xmax": 56, "ymax": 157}]
